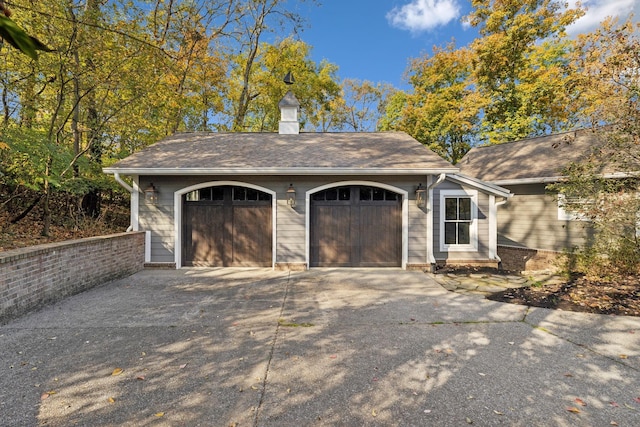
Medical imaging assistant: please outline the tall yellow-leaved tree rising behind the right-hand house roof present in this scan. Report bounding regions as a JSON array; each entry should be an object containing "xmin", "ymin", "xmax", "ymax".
[{"xmin": 467, "ymin": 0, "xmax": 583, "ymax": 143}]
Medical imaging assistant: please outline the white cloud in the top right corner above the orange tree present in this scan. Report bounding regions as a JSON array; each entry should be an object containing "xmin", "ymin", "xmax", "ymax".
[{"xmin": 567, "ymin": 0, "xmax": 640, "ymax": 36}]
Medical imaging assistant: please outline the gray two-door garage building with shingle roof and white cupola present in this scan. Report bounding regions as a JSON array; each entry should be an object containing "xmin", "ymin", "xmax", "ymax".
[{"xmin": 104, "ymin": 93, "xmax": 511, "ymax": 269}]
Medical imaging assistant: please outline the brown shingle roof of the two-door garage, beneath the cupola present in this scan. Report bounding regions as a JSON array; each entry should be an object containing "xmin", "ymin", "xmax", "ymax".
[{"xmin": 104, "ymin": 132, "xmax": 458, "ymax": 175}]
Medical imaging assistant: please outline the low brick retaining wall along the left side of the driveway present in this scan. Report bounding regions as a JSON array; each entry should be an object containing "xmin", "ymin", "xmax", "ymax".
[{"xmin": 0, "ymin": 232, "xmax": 145, "ymax": 324}]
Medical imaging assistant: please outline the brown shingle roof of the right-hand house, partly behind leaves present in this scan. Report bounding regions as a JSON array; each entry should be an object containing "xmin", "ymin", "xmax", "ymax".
[{"xmin": 457, "ymin": 129, "xmax": 607, "ymax": 184}]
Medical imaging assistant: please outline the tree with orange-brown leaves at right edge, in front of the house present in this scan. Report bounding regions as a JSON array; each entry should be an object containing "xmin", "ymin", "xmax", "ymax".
[{"xmin": 551, "ymin": 19, "xmax": 640, "ymax": 275}]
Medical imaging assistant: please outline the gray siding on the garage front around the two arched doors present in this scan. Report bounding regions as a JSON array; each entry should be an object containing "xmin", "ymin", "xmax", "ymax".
[{"xmin": 139, "ymin": 176, "xmax": 427, "ymax": 264}]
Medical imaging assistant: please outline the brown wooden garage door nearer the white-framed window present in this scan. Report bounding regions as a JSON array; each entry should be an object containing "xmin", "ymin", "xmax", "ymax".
[{"xmin": 310, "ymin": 186, "xmax": 402, "ymax": 267}]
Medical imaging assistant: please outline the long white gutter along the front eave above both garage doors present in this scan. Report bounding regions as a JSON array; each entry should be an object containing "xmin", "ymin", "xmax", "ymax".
[{"xmin": 102, "ymin": 168, "xmax": 458, "ymax": 175}]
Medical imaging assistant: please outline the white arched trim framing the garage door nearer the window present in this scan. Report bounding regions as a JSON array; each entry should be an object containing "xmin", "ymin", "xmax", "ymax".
[{"xmin": 304, "ymin": 181, "xmax": 409, "ymax": 270}]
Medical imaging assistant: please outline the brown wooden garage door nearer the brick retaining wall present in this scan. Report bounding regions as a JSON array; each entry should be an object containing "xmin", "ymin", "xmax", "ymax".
[{"xmin": 183, "ymin": 186, "xmax": 272, "ymax": 267}]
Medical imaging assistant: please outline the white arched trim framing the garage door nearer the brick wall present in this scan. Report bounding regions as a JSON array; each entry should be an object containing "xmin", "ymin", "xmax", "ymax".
[{"xmin": 173, "ymin": 181, "xmax": 277, "ymax": 269}]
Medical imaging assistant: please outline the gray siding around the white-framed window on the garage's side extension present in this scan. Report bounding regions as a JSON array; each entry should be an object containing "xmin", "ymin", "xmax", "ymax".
[{"xmin": 433, "ymin": 181, "xmax": 489, "ymax": 261}]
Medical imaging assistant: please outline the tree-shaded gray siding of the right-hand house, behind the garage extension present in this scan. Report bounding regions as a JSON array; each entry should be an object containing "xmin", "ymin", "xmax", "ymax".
[{"xmin": 498, "ymin": 184, "xmax": 591, "ymax": 251}]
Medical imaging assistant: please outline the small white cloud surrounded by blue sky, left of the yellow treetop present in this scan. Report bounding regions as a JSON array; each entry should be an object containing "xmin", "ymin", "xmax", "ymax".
[{"xmin": 387, "ymin": 0, "xmax": 460, "ymax": 33}]
